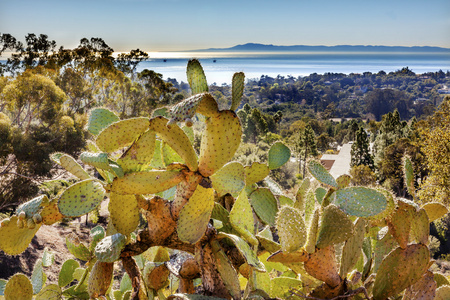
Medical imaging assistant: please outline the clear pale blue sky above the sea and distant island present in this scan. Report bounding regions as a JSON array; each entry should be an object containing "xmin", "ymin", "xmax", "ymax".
[{"xmin": 0, "ymin": 0, "xmax": 450, "ymax": 51}]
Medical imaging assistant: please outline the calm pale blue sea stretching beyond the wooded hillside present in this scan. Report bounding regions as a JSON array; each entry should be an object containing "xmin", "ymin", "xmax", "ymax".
[{"xmin": 139, "ymin": 52, "xmax": 450, "ymax": 85}]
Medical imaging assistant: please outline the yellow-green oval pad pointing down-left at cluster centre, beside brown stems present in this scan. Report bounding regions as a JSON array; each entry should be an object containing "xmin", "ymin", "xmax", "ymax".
[{"xmin": 177, "ymin": 185, "xmax": 214, "ymax": 244}]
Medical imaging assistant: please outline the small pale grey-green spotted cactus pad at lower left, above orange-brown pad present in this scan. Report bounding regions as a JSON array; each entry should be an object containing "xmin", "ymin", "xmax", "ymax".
[{"xmin": 95, "ymin": 233, "xmax": 127, "ymax": 263}]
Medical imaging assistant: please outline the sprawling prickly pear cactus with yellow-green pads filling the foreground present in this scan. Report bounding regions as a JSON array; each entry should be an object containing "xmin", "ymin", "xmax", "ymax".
[{"xmin": 0, "ymin": 60, "xmax": 449, "ymax": 300}]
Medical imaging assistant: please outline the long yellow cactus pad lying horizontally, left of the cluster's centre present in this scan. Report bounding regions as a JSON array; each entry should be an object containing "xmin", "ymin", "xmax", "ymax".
[{"xmin": 111, "ymin": 170, "xmax": 184, "ymax": 195}]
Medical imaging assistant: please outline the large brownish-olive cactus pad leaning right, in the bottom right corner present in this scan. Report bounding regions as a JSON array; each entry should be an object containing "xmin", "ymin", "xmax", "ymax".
[{"xmin": 373, "ymin": 244, "xmax": 430, "ymax": 300}]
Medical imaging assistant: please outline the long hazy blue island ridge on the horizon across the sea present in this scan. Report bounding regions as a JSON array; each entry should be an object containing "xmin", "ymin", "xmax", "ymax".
[{"xmin": 195, "ymin": 43, "xmax": 450, "ymax": 53}]
